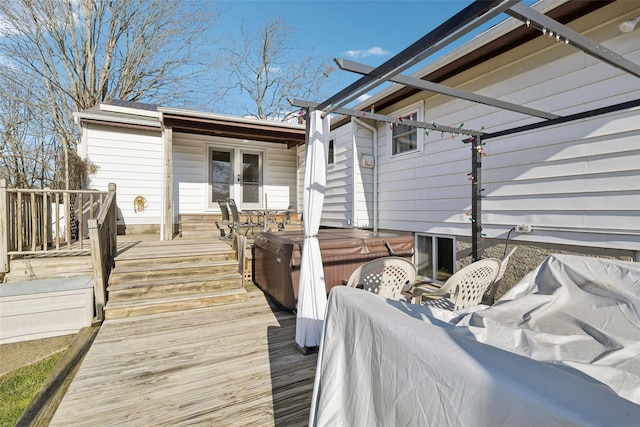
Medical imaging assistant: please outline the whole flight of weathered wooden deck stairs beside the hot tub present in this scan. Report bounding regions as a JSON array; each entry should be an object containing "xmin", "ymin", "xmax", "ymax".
[{"xmin": 104, "ymin": 238, "xmax": 247, "ymax": 319}]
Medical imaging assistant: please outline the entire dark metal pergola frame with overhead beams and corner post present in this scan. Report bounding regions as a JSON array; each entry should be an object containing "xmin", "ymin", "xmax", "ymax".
[{"xmin": 306, "ymin": 0, "xmax": 640, "ymax": 261}]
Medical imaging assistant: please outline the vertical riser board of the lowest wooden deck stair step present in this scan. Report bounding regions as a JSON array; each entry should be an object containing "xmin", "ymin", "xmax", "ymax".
[{"xmin": 104, "ymin": 293, "xmax": 247, "ymax": 320}]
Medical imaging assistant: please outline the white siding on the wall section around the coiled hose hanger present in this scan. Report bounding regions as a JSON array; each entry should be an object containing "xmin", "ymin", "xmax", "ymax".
[{"xmin": 85, "ymin": 125, "xmax": 162, "ymax": 225}]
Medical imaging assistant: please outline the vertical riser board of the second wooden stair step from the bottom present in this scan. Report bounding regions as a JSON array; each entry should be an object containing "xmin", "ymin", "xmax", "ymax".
[{"xmin": 107, "ymin": 277, "xmax": 242, "ymax": 302}]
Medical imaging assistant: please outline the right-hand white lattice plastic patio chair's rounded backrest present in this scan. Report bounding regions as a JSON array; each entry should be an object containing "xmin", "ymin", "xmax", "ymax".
[{"xmin": 446, "ymin": 258, "xmax": 502, "ymax": 310}]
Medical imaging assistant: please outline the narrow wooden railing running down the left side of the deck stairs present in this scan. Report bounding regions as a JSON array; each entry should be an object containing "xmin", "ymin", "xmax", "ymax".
[{"xmin": 88, "ymin": 184, "xmax": 118, "ymax": 320}]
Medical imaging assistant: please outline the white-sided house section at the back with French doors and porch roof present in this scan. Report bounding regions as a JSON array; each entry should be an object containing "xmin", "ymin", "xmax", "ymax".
[{"xmin": 76, "ymin": 100, "xmax": 305, "ymax": 240}]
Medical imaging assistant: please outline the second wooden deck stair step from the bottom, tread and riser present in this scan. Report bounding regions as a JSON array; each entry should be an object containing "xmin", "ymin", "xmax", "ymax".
[{"xmin": 107, "ymin": 273, "xmax": 242, "ymax": 301}]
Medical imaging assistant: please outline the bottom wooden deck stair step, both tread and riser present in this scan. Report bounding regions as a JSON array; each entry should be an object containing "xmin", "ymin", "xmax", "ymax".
[{"xmin": 104, "ymin": 288, "xmax": 247, "ymax": 319}]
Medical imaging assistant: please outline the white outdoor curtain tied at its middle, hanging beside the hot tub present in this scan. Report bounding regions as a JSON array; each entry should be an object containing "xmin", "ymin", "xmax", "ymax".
[{"xmin": 296, "ymin": 111, "xmax": 329, "ymax": 348}]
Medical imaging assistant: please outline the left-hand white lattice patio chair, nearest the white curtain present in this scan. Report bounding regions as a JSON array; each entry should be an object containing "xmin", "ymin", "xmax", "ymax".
[{"xmin": 347, "ymin": 256, "xmax": 416, "ymax": 300}]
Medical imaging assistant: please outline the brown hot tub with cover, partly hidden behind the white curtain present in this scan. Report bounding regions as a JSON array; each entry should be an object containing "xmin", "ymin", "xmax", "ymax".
[{"xmin": 253, "ymin": 229, "xmax": 413, "ymax": 310}]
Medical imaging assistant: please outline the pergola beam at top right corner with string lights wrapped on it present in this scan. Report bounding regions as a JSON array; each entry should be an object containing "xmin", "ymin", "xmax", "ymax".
[{"xmin": 506, "ymin": 3, "xmax": 640, "ymax": 77}]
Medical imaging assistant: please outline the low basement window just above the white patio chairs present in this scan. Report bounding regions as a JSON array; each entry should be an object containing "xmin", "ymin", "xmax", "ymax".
[{"xmin": 416, "ymin": 234, "xmax": 456, "ymax": 282}]
